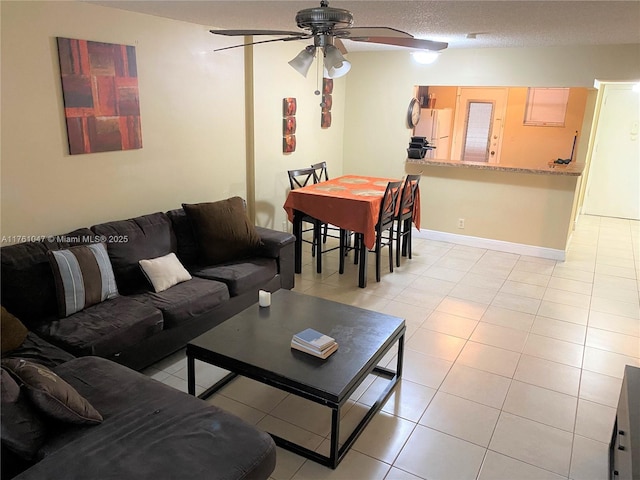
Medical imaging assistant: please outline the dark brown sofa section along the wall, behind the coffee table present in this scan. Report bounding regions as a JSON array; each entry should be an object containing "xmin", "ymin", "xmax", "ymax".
[{"xmin": 0, "ymin": 199, "xmax": 294, "ymax": 370}]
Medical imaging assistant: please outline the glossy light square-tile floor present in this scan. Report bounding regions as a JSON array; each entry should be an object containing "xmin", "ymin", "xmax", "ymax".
[{"xmin": 147, "ymin": 216, "xmax": 640, "ymax": 480}]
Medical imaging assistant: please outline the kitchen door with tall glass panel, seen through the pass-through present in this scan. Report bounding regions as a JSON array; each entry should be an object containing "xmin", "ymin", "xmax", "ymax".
[{"xmin": 451, "ymin": 87, "xmax": 508, "ymax": 163}]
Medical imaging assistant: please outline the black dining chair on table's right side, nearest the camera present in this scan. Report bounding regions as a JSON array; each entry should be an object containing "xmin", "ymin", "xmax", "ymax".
[{"xmin": 354, "ymin": 181, "xmax": 402, "ymax": 282}]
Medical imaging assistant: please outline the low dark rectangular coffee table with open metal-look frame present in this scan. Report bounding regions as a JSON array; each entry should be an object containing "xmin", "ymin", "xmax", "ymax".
[{"xmin": 187, "ymin": 290, "xmax": 405, "ymax": 468}]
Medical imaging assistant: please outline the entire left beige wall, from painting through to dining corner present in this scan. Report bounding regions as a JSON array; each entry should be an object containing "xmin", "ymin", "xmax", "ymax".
[{"xmin": 0, "ymin": 1, "xmax": 345, "ymax": 243}]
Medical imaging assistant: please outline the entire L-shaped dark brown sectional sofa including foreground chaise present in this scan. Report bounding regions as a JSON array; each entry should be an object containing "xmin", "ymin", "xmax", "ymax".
[{"xmin": 0, "ymin": 197, "xmax": 295, "ymax": 480}]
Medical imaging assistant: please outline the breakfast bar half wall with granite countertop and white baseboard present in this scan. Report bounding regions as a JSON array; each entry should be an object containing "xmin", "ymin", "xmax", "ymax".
[{"xmin": 405, "ymin": 157, "xmax": 584, "ymax": 260}]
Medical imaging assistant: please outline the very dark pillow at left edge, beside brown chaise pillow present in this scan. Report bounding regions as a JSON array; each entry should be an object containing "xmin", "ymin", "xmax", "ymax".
[{"xmin": 0, "ymin": 368, "xmax": 46, "ymax": 460}]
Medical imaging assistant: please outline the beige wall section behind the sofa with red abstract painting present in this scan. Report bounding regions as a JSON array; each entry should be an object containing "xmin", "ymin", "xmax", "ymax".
[{"xmin": 1, "ymin": 2, "xmax": 246, "ymax": 239}]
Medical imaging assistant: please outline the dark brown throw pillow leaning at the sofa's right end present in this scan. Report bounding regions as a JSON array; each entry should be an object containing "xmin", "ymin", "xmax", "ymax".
[{"xmin": 182, "ymin": 197, "xmax": 262, "ymax": 265}]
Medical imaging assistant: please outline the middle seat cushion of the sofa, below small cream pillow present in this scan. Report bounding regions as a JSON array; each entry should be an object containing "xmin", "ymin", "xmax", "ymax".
[{"xmin": 131, "ymin": 278, "xmax": 229, "ymax": 330}]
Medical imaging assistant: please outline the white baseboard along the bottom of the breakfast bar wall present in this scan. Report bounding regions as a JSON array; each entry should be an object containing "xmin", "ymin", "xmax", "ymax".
[{"xmin": 413, "ymin": 228, "xmax": 566, "ymax": 261}]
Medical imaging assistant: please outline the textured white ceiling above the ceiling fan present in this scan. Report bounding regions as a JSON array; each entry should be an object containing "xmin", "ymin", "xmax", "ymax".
[{"xmin": 89, "ymin": 0, "xmax": 640, "ymax": 51}]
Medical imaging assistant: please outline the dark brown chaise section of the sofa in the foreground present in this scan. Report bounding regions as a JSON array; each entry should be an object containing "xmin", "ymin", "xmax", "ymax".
[{"xmin": 0, "ymin": 332, "xmax": 276, "ymax": 480}]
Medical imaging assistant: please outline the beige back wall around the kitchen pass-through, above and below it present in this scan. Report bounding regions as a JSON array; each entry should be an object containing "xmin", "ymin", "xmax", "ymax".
[{"xmin": 344, "ymin": 45, "xmax": 640, "ymax": 250}]
